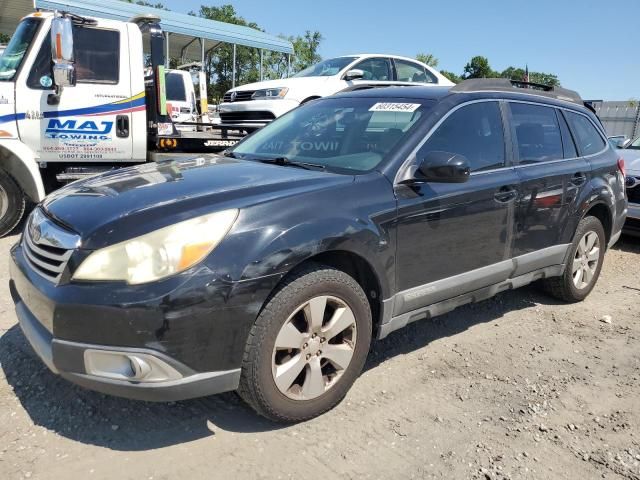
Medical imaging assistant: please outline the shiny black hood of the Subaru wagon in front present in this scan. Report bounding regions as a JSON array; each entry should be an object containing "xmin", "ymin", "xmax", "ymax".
[{"xmin": 42, "ymin": 155, "xmax": 354, "ymax": 249}]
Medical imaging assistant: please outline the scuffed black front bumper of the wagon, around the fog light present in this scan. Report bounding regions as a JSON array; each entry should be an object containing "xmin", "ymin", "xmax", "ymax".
[{"xmin": 10, "ymin": 245, "xmax": 262, "ymax": 401}]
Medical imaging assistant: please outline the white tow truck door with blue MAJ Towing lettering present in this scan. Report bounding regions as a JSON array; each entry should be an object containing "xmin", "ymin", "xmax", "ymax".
[{"xmin": 16, "ymin": 21, "xmax": 137, "ymax": 162}]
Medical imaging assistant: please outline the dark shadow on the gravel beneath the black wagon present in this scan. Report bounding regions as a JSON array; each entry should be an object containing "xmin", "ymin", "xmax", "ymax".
[{"xmin": 0, "ymin": 287, "xmax": 554, "ymax": 451}]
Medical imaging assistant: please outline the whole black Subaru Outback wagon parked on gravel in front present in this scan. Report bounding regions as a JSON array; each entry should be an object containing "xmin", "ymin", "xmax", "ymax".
[{"xmin": 10, "ymin": 80, "xmax": 627, "ymax": 421}]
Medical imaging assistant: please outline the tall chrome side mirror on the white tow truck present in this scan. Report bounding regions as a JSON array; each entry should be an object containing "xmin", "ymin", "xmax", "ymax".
[{"xmin": 51, "ymin": 17, "xmax": 76, "ymax": 95}]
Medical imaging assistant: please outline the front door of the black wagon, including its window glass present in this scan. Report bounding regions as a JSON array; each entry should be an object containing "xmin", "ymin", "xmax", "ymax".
[{"xmin": 394, "ymin": 101, "xmax": 519, "ymax": 315}]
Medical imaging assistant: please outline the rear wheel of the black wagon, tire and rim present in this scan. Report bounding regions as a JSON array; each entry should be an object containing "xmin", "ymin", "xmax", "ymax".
[{"xmin": 543, "ymin": 216, "xmax": 607, "ymax": 303}]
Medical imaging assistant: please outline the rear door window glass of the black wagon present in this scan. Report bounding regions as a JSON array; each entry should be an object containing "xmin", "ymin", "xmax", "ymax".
[{"xmin": 509, "ymin": 103, "xmax": 564, "ymax": 164}]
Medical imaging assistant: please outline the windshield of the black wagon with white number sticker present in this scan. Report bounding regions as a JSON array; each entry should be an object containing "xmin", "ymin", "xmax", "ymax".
[{"xmin": 231, "ymin": 98, "xmax": 435, "ymax": 174}]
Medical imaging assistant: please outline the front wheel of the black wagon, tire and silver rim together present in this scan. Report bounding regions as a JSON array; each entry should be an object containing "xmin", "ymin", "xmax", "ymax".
[{"xmin": 238, "ymin": 264, "xmax": 372, "ymax": 423}]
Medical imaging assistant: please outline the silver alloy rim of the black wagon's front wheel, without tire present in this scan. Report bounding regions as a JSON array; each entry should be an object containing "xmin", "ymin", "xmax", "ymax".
[{"xmin": 272, "ymin": 295, "xmax": 356, "ymax": 400}]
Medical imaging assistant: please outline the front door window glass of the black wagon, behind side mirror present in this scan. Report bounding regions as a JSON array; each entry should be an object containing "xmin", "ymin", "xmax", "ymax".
[{"xmin": 418, "ymin": 102, "xmax": 505, "ymax": 172}]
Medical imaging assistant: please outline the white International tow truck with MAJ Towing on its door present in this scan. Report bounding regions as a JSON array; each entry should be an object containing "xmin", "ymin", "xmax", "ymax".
[{"xmin": 0, "ymin": 11, "xmax": 247, "ymax": 236}]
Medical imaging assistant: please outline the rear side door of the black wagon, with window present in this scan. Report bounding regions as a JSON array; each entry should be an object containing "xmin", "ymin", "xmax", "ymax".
[{"xmin": 508, "ymin": 101, "xmax": 591, "ymax": 258}]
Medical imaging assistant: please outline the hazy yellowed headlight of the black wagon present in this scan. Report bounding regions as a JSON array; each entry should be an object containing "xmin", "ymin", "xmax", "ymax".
[{"xmin": 73, "ymin": 209, "xmax": 238, "ymax": 285}]
